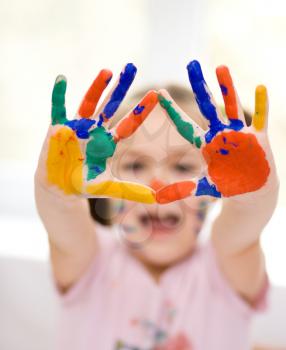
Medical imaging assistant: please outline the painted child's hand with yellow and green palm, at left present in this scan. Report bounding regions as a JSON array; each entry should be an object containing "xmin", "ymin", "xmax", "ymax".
[{"xmin": 36, "ymin": 64, "xmax": 157, "ymax": 203}]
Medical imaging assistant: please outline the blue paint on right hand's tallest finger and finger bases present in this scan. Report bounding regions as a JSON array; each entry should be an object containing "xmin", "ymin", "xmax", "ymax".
[{"xmin": 187, "ymin": 61, "xmax": 243, "ymax": 143}]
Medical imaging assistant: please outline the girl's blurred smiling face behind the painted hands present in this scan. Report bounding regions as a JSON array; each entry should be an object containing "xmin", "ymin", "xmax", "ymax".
[{"xmin": 112, "ymin": 105, "xmax": 208, "ymax": 267}]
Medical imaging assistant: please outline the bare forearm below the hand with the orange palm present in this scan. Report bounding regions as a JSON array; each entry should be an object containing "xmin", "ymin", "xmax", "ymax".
[{"xmin": 212, "ymin": 184, "xmax": 278, "ymax": 304}]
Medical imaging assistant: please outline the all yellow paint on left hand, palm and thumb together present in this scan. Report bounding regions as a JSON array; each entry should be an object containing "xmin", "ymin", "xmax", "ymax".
[{"xmin": 47, "ymin": 126, "xmax": 156, "ymax": 204}]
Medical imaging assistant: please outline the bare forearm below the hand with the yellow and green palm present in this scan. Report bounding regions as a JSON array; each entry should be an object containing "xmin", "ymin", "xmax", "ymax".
[{"xmin": 35, "ymin": 180, "xmax": 98, "ymax": 291}]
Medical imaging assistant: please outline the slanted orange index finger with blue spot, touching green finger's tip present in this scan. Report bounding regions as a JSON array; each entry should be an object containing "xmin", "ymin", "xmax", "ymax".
[{"xmin": 114, "ymin": 90, "xmax": 158, "ymax": 142}]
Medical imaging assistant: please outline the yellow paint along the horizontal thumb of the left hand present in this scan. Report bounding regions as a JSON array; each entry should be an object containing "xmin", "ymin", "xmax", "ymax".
[{"xmin": 86, "ymin": 181, "xmax": 156, "ymax": 204}]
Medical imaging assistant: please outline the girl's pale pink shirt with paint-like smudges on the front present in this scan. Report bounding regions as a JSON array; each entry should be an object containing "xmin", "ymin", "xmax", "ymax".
[{"xmin": 54, "ymin": 225, "xmax": 269, "ymax": 350}]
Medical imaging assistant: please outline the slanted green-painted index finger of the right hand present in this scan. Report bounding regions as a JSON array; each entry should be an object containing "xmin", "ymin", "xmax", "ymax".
[{"xmin": 158, "ymin": 89, "xmax": 204, "ymax": 148}]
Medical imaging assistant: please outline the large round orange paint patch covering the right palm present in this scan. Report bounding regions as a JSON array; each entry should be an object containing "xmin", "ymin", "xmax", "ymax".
[{"xmin": 202, "ymin": 131, "xmax": 270, "ymax": 197}]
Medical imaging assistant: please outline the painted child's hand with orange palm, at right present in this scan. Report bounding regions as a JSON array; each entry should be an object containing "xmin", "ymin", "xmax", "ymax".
[{"xmin": 156, "ymin": 61, "xmax": 278, "ymax": 203}]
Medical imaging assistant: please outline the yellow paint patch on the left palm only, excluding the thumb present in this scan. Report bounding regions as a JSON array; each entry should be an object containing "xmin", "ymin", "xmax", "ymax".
[{"xmin": 47, "ymin": 126, "xmax": 84, "ymax": 194}]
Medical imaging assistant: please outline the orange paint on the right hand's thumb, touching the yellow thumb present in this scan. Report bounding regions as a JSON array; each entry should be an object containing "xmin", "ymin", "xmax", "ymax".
[{"xmin": 156, "ymin": 181, "xmax": 196, "ymax": 204}]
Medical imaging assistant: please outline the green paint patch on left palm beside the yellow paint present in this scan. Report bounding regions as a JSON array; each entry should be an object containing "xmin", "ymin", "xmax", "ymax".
[{"xmin": 86, "ymin": 127, "xmax": 116, "ymax": 180}]
